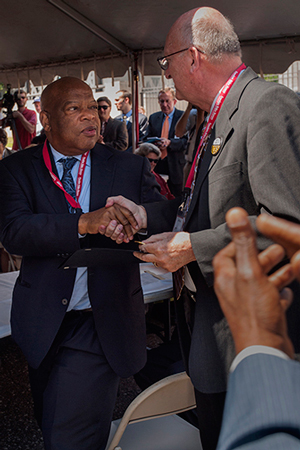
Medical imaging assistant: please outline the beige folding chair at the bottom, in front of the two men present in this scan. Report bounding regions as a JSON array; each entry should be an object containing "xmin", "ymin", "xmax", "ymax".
[{"xmin": 106, "ymin": 372, "xmax": 202, "ymax": 450}]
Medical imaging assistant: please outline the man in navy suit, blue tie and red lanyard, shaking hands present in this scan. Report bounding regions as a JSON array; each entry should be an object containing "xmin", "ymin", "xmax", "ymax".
[{"xmin": 0, "ymin": 77, "xmax": 161, "ymax": 450}]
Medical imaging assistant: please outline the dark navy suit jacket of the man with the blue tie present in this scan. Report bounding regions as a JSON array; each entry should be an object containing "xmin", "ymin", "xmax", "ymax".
[{"xmin": 0, "ymin": 144, "xmax": 161, "ymax": 377}]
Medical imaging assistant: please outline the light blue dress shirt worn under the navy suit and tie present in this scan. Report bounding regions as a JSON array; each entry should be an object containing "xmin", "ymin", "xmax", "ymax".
[{"xmin": 50, "ymin": 145, "xmax": 91, "ymax": 311}]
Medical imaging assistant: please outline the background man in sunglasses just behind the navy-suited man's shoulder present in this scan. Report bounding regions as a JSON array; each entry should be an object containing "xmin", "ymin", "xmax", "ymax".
[{"xmin": 97, "ymin": 97, "xmax": 128, "ymax": 151}]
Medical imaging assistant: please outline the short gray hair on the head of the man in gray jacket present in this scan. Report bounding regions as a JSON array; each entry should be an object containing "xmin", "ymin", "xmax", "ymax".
[{"xmin": 183, "ymin": 10, "xmax": 242, "ymax": 63}]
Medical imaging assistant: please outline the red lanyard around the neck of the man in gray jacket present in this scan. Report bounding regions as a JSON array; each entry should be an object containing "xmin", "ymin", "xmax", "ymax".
[{"xmin": 185, "ymin": 64, "xmax": 246, "ymax": 188}]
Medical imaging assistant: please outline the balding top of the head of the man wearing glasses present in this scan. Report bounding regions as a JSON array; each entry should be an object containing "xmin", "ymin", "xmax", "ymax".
[{"xmin": 166, "ymin": 7, "xmax": 241, "ymax": 63}]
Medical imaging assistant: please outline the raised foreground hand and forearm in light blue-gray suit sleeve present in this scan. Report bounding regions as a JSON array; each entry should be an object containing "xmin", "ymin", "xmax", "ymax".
[{"xmin": 214, "ymin": 208, "xmax": 300, "ymax": 450}]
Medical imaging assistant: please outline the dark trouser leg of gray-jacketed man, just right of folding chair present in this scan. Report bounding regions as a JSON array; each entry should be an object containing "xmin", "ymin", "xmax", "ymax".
[{"xmin": 195, "ymin": 389, "xmax": 226, "ymax": 450}]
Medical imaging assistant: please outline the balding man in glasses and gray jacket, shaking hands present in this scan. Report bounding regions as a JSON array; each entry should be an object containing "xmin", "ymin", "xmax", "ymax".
[{"xmin": 106, "ymin": 8, "xmax": 300, "ymax": 449}]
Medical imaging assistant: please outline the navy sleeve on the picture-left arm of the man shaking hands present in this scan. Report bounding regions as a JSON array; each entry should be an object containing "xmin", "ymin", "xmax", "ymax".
[{"xmin": 0, "ymin": 159, "xmax": 80, "ymax": 257}]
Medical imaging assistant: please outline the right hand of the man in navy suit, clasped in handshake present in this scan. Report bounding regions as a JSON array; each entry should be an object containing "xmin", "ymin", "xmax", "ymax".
[{"xmin": 78, "ymin": 204, "xmax": 138, "ymax": 244}]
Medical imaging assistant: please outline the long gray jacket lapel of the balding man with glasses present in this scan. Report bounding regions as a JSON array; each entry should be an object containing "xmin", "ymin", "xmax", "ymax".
[{"xmin": 185, "ymin": 68, "xmax": 257, "ymax": 225}]
